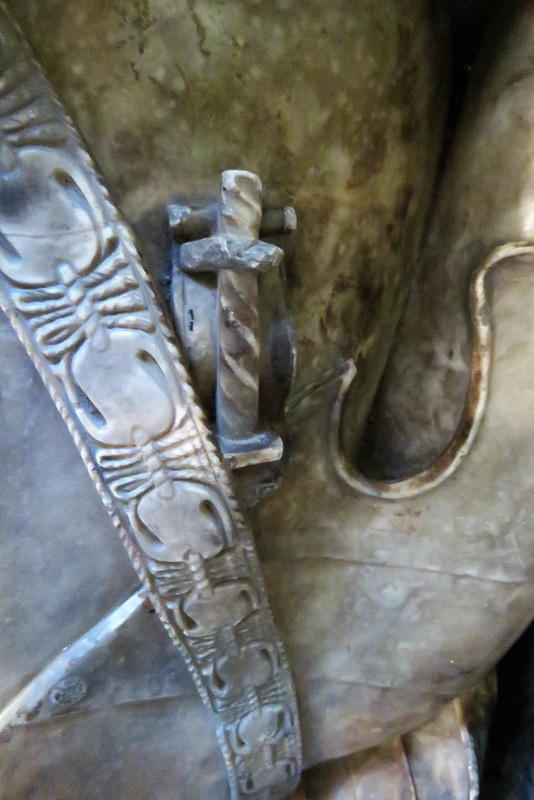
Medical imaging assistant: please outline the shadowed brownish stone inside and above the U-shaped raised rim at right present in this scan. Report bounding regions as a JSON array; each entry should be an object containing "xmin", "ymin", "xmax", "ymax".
[{"xmin": 361, "ymin": 0, "xmax": 534, "ymax": 477}]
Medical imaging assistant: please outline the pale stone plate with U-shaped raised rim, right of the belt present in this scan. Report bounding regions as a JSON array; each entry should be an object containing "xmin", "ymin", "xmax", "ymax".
[{"xmin": 255, "ymin": 247, "xmax": 534, "ymax": 760}]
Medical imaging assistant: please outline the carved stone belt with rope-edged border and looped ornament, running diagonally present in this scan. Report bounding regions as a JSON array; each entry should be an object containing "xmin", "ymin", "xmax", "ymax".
[{"xmin": 0, "ymin": 4, "xmax": 301, "ymax": 800}]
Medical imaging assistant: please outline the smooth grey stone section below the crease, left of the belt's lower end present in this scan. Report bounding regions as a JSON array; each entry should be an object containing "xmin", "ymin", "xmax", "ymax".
[{"xmin": 0, "ymin": 696, "xmax": 230, "ymax": 800}]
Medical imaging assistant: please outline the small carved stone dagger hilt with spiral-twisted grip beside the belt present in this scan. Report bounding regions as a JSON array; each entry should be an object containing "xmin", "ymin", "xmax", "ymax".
[{"xmin": 180, "ymin": 170, "xmax": 294, "ymax": 468}]
